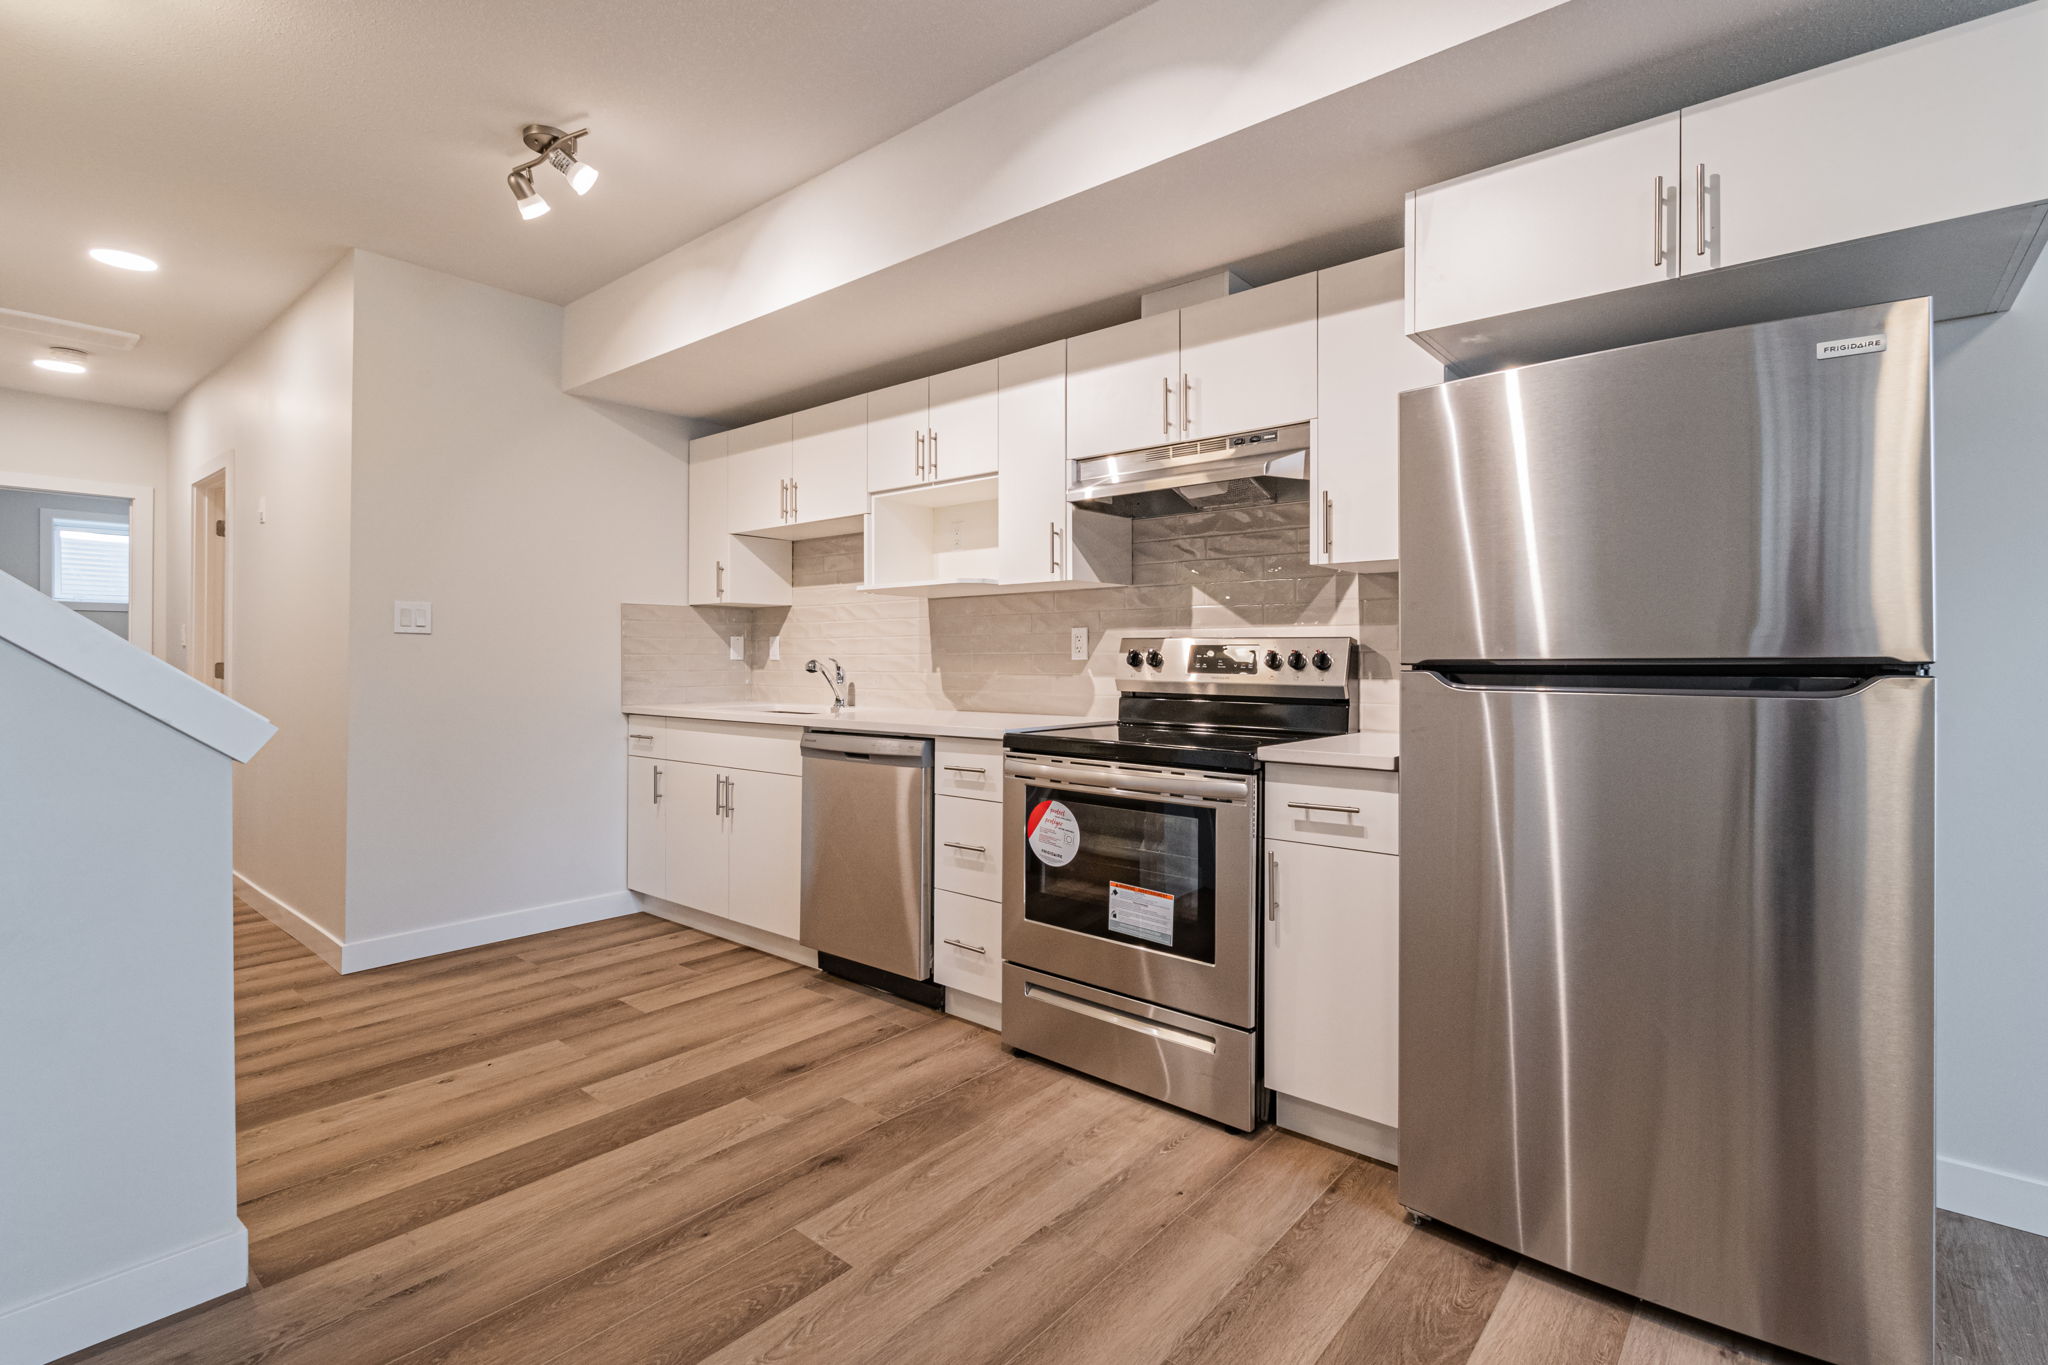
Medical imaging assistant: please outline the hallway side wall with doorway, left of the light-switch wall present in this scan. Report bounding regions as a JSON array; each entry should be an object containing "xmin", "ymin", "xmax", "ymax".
[{"xmin": 166, "ymin": 260, "xmax": 354, "ymax": 958}]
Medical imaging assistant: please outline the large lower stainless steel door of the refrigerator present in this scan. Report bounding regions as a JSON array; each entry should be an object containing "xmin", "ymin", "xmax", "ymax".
[{"xmin": 1401, "ymin": 671, "xmax": 1933, "ymax": 1365}]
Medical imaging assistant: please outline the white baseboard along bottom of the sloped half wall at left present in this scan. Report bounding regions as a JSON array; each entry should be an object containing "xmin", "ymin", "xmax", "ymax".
[{"xmin": 0, "ymin": 1222, "xmax": 250, "ymax": 1365}]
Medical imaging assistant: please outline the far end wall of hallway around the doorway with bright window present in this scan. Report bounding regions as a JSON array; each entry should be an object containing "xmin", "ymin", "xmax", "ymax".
[{"xmin": 0, "ymin": 389, "xmax": 172, "ymax": 657}]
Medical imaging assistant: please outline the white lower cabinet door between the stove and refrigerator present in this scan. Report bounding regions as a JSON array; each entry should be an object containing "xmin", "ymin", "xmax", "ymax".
[{"xmin": 1264, "ymin": 841, "xmax": 1401, "ymax": 1128}]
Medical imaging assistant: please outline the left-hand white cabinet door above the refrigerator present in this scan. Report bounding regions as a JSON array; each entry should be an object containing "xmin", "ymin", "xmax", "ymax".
[{"xmin": 1407, "ymin": 115, "xmax": 1681, "ymax": 332}]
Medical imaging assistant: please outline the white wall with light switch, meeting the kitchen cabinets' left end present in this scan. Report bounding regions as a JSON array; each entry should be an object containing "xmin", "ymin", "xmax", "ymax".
[{"xmin": 344, "ymin": 252, "xmax": 696, "ymax": 970}]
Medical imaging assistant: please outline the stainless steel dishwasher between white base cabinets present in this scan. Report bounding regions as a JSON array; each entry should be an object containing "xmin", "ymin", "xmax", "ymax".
[{"xmin": 801, "ymin": 731, "xmax": 944, "ymax": 1007}]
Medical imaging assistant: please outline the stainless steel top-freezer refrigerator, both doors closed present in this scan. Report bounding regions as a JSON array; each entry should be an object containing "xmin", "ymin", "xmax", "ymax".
[{"xmin": 1401, "ymin": 299, "xmax": 1935, "ymax": 1365}]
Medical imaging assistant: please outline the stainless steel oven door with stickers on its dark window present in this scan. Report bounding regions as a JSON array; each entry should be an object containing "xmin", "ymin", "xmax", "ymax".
[{"xmin": 1004, "ymin": 755, "xmax": 1260, "ymax": 1027}]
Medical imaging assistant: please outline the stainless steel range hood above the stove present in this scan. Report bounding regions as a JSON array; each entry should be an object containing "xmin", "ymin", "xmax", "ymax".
[{"xmin": 1067, "ymin": 422, "xmax": 1309, "ymax": 518}]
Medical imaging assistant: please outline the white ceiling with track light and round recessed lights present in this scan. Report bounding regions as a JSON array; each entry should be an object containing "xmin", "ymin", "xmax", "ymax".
[{"xmin": 0, "ymin": 0, "xmax": 1145, "ymax": 409}]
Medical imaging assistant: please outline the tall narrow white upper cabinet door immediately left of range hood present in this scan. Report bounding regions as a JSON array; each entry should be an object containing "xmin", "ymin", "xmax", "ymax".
[{"xmin": 995, "ymin": 342, "xmax": 1071, "ymax": 589}]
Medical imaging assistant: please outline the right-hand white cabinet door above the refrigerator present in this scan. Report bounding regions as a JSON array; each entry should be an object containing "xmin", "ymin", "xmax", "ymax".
[{"xmin": 1681, "ymin": 4, "xmax": 2048, "ymax": 270}]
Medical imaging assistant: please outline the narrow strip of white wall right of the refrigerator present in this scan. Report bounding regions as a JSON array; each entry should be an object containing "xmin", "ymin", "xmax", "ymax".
[{"xmin": 1935, "ymin": 270, "xmax": 2048, "ymax": 1236}]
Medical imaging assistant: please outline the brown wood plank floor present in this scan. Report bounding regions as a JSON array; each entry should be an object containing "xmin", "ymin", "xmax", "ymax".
[{"xmin": 74, "ymin": 905, "xmax": 2048, "ymax": 1365}]
